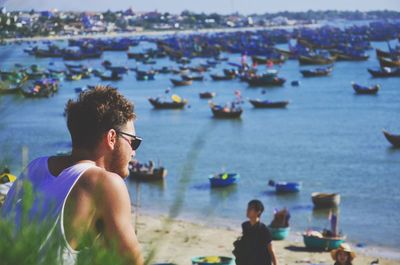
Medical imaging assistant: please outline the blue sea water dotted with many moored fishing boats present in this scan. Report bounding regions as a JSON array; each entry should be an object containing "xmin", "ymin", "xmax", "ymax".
[{"xmin": 0, "ymin": 34, "xmax": 400, "ymax": 250}]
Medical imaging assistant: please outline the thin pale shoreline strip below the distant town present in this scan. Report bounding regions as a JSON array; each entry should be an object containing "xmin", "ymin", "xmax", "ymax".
[{"xmin": 3, "ymin": 23, "xmax": 321, "ymax": 44}]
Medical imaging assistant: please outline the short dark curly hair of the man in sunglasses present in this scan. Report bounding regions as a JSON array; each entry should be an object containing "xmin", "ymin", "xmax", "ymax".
[{"xmin": 65, "ymin": 86, "xmax": 136, "ymax": 148}]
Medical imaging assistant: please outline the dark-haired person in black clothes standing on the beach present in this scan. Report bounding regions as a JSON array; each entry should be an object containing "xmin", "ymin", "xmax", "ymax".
[{"xmin": 237, "ymin": 200, "xmax": 278, "ymax": 265}]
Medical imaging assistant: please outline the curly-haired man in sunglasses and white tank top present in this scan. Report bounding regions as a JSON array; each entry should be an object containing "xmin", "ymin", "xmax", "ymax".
[{"xmin": 2, "ymin": 87, "xmax": 143, "ymax": 265}]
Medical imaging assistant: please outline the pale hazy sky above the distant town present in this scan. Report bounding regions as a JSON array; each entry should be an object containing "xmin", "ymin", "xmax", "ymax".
[{"xmin": 0, "ymin": 0, "xmax": 400, "ymax": 14}]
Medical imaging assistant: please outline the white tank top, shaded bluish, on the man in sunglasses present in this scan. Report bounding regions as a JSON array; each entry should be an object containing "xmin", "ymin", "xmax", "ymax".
[{"xmin": 1, "ymin": 157, "xmax": 95, "ymax": 265}]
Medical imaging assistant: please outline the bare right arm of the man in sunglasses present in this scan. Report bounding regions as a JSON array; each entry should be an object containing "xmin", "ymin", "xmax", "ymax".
[{"xmin": 98, "ymin": 173, "xmax": 144, "ymax": 265}]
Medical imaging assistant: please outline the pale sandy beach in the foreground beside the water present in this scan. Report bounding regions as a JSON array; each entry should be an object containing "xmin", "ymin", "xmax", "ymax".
[{"xmin": 136, "ymin": 214, "xmax": 400, "ymax": 265}]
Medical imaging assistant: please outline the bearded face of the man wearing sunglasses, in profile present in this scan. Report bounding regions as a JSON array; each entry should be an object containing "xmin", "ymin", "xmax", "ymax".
[{"xmin": 111, "ymin": 121, "xmax": 136, "ymax": 178}]
